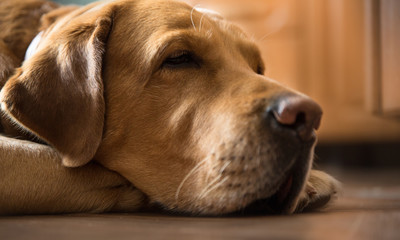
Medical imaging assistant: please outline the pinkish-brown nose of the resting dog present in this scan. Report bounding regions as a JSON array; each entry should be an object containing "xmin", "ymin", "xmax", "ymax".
[{"xmin": 269, "ymin": 95, "xmax": 322, "ymax": 141}]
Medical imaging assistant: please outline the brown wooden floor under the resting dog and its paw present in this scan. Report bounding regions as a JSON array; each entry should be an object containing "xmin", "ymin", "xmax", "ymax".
[{"xmin": 0, "ymin": 169, "xmax": 400, "ymax": 240}]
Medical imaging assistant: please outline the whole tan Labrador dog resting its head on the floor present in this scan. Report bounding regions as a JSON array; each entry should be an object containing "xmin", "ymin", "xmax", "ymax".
[{"xmin": 0, "ymin": 0, "xmax": 339, "ymax": 215}]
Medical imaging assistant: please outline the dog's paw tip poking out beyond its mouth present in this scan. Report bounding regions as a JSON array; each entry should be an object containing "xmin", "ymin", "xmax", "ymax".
[{"xmin": 295, "ymin": 170, "xmax": 340, "ymax": 212}]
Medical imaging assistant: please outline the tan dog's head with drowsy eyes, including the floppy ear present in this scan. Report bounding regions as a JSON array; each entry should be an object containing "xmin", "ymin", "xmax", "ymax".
[{"xmin": 1, "ymin": 0, "xmax": 321, "ymax": 214}]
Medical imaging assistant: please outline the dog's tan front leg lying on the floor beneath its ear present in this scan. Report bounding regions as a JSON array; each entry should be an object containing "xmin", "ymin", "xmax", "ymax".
[{"xmin": 0, "ymin": 136, "xmax": 146, "ymax": 215}]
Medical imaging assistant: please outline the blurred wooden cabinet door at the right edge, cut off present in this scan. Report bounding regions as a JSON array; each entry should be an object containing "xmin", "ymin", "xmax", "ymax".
[{"xmin": 365, "ymin": 0, "xmax": 400, "ymax": 117}]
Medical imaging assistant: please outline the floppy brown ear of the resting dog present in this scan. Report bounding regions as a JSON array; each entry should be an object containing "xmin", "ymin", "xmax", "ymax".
[{"xmin": 0, "ymin": 6, "xmax": 112, "ymax": 167}]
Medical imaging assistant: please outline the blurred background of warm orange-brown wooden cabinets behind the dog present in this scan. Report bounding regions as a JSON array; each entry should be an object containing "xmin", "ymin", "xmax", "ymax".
[{"xmin": 54, "ymin": 0, "xmax": 400, "ymax": 169}]
